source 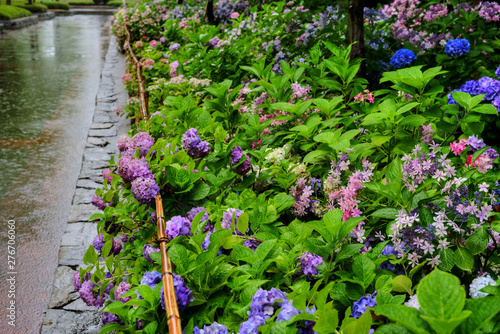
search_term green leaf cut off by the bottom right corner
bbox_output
[457,297,500,334]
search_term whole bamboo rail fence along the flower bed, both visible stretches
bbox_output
[124,22,182,334]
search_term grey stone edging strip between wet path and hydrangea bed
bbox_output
[40,36,130,334]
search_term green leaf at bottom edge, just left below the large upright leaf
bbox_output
[373,304,429,334]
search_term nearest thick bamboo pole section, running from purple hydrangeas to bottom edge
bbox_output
[156,194,182,334]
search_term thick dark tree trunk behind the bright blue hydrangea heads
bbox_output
[347,0,366,78]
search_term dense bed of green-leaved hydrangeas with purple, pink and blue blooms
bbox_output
[74,0,500,334]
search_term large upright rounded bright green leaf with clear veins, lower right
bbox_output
[417,269,465,320]
